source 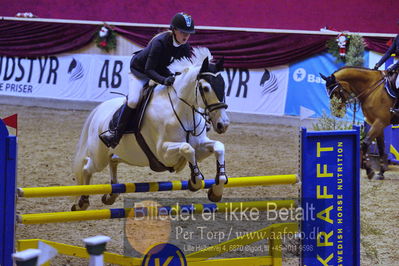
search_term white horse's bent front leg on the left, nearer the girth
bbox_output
[163,142,204,191]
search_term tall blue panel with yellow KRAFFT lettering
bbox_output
[301,128,360,265]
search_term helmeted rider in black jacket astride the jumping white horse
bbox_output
[100,12,195,148]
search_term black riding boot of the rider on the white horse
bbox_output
[99,103,134,149]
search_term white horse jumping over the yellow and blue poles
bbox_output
[72,48,229,210]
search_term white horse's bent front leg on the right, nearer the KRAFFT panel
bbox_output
[197,139,228,202]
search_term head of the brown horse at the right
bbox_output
[320,73,351,117]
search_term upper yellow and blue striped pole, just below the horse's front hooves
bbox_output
[18,175,297,198]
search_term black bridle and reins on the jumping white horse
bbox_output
[168,72,228,142]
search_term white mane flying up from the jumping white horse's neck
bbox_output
[168,47,212,73]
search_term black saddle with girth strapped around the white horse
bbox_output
[109,83,175,173]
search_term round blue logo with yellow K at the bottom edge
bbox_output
[141,243,187,266]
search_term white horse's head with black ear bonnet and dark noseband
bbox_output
[197,57,230,134]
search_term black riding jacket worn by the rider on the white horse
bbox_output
[130,32,191,84]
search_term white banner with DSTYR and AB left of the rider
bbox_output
[0,54,130,101]
